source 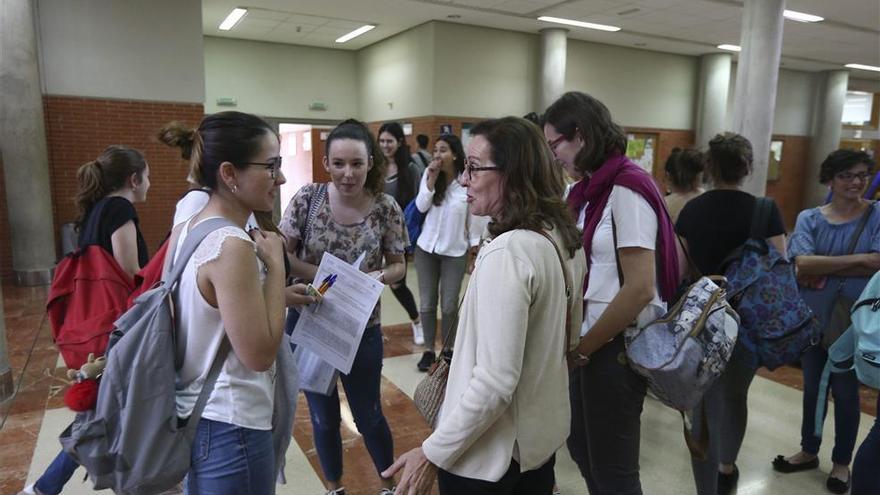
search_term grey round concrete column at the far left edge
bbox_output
[0,0,56,285]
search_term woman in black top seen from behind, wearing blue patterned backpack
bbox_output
[675,133,785,495]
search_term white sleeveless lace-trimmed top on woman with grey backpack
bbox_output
[173,219,275,430]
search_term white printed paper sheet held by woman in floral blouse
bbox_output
[292,252,385,373]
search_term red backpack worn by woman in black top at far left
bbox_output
[46,245,135,370]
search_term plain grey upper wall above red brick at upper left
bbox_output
[37,0,205,103]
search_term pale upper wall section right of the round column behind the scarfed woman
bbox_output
[565,40,700,129]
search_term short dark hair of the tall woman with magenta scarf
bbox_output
[544,91,626,174]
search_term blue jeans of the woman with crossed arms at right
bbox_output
[801,345,859,466]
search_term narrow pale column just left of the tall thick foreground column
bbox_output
[696,53,733,149]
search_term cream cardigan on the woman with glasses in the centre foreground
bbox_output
[422,230,587,482]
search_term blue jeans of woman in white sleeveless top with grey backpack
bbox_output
[184,418,275,495]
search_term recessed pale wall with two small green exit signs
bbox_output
[205,36,358,119]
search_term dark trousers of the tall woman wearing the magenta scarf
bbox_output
[569,335,647,495]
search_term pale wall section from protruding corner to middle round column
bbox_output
[433,22,539,117]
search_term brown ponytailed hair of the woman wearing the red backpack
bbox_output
[74,145,147,227]
